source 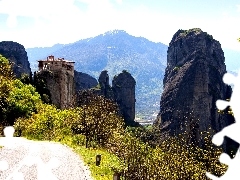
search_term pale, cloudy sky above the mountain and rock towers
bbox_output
[0,0,240,51]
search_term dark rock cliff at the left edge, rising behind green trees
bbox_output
[0,41,31,78]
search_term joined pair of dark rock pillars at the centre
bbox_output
[93,70,139,126]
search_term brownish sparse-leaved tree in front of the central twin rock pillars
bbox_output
[72,90,124,147]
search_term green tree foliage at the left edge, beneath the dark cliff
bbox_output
[0,55,41,125]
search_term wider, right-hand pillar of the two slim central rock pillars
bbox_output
[112,70,137,125]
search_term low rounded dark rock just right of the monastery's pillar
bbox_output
[74,71,98,92]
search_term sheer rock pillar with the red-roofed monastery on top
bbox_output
[34,56,75,109]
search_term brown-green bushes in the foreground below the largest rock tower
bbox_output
[106,128,227,180]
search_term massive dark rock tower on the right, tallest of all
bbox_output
[155,29,232,146]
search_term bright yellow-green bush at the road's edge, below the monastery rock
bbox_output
[14,104,74,140]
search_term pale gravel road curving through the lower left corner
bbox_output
[0,137,93,180]
